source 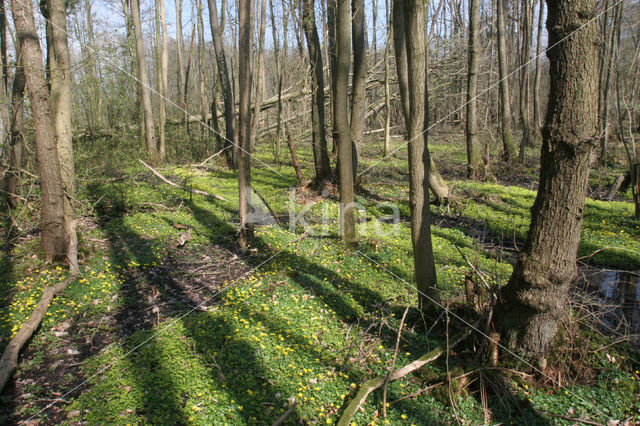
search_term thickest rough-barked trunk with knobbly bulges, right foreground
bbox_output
[496,0,598,365]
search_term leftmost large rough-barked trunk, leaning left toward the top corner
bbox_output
[11,0,67,262]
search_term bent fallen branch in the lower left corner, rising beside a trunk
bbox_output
[0,220,78,392]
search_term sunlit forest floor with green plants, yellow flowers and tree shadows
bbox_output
[0,131,640,424]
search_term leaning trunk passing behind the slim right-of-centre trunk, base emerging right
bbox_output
[392,1,449,203]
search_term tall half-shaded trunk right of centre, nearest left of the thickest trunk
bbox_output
[393,0,440,309]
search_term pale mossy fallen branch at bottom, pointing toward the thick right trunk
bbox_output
[338,330,470,426]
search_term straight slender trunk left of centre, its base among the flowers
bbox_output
[238,0,253,249]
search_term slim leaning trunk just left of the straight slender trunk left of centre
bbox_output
[208,0,236,168]
